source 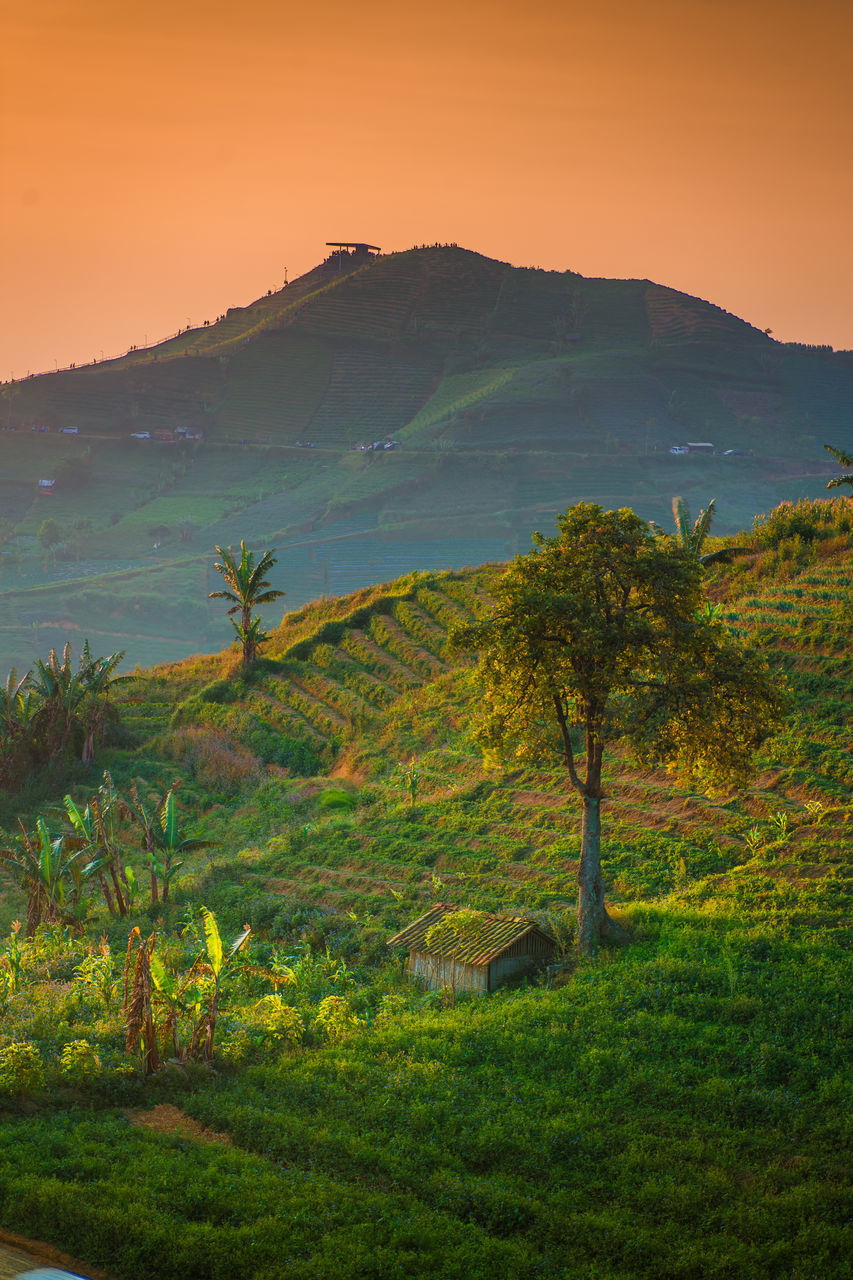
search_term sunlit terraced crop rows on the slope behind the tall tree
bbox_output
[112,509,853,942]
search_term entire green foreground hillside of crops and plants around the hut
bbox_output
[0,499,853,1280]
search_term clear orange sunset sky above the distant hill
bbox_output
[0,0,853,378]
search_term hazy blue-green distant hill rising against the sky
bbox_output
[0,247,853,671]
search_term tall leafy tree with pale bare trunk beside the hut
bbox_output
[455,503,783,954]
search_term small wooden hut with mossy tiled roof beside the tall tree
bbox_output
[388,902,557,995]
